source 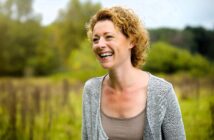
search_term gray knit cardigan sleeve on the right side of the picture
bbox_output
[162,86,186,140]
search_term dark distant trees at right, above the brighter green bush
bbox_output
[149,26,214,60]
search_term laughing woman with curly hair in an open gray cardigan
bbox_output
[82,7,185,140]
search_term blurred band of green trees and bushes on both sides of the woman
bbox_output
[0,0,214,77]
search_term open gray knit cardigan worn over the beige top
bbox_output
[82,74,186,140]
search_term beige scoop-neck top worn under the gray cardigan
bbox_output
[101,110,145,140]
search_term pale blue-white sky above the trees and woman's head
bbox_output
[33,0,214,29]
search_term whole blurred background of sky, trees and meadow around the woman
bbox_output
[0,0,214,140]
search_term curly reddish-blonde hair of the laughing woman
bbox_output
[86,6,149,67]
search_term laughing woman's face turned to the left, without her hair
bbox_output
[92,20,133,69]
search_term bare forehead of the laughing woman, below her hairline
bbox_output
[93,20,118,35]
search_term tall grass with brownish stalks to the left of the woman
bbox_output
[0,79,81,140]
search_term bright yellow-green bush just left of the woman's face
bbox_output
[68,39,105,81]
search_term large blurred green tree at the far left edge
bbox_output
[0,0,59,76]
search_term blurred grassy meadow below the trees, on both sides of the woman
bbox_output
[0,75,214,140]
